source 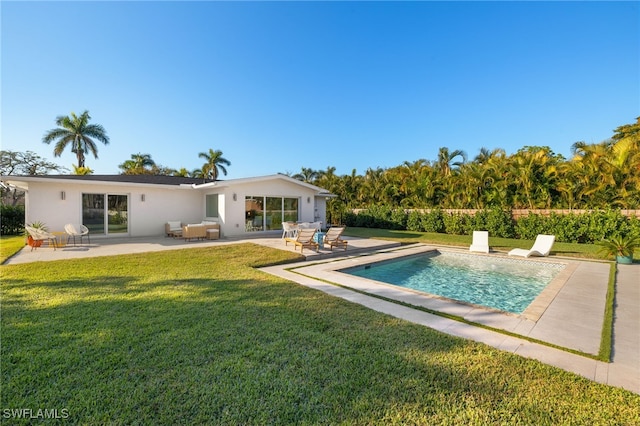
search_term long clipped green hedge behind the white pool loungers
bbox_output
[345,206,640,243]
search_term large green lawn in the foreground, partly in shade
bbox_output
[0,244,640,425]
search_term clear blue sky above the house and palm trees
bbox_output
[0,1,640,178]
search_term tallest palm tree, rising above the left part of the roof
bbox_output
[42,111,109,167]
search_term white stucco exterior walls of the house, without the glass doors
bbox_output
[15,176,326,238]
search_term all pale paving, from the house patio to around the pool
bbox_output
[5,234,640,394]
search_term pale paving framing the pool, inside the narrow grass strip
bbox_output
[288,244,610,356]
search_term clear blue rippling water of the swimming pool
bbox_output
[342,252,565,314]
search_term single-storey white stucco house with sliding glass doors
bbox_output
[1,174,334,238]
